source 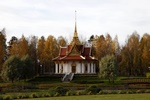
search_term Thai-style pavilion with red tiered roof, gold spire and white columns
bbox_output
[53,18,97,74]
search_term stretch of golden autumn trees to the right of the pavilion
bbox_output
[91,32,150,76]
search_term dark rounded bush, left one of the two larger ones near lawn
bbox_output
[49,86,68,96]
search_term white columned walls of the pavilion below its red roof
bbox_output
[55,61,96,74]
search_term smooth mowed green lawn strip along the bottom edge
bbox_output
[22,94,150,100]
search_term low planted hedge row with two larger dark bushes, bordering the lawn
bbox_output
[0,86,150,100]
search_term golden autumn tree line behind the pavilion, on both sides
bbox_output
[0,29,150,82]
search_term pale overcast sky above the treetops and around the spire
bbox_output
[0,0,150,44]
